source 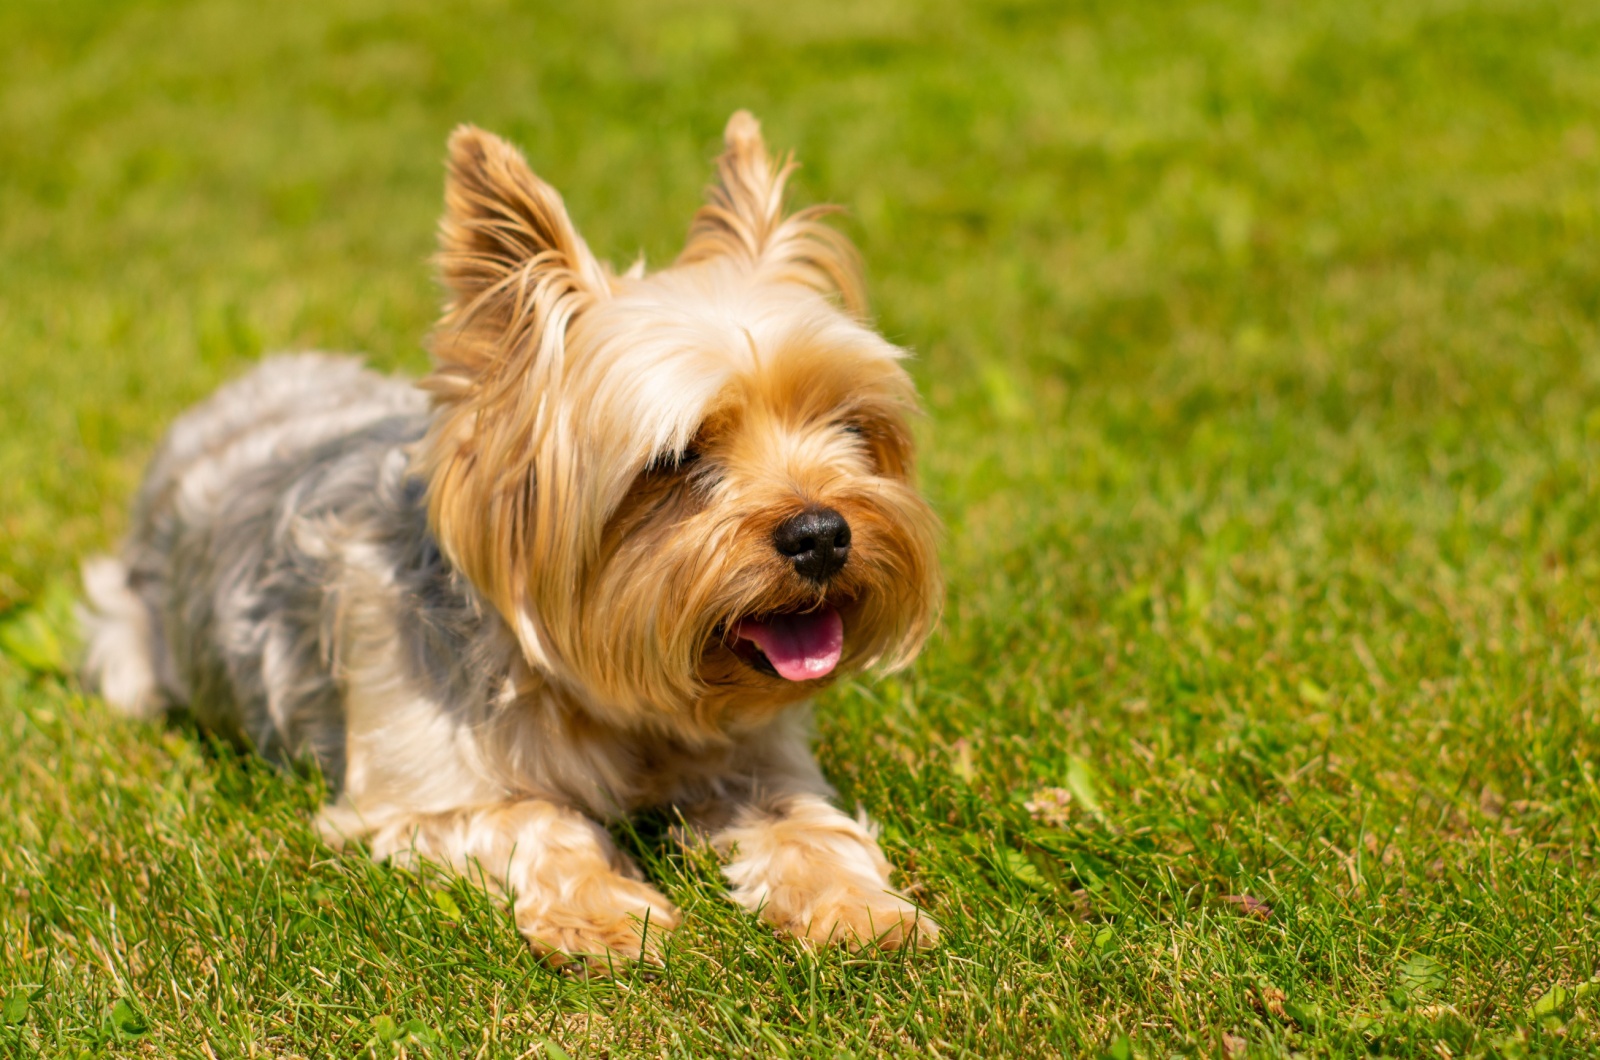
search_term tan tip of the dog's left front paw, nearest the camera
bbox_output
[517,879,678,972]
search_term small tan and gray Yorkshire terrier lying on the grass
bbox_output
[85,110,941,970]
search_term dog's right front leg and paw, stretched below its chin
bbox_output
[710,794,939,950]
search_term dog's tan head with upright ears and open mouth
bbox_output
[424,112,939,733]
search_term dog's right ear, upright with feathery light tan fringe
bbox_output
[678,110,867,317]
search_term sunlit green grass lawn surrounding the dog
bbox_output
[0,0,1600,1057]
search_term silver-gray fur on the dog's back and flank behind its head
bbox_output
[88,354,506,789]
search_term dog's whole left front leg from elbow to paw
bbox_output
[318,799,678,970]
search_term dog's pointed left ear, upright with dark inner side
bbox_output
[432,125,610,381]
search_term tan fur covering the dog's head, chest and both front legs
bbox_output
[363,112,939,956]
